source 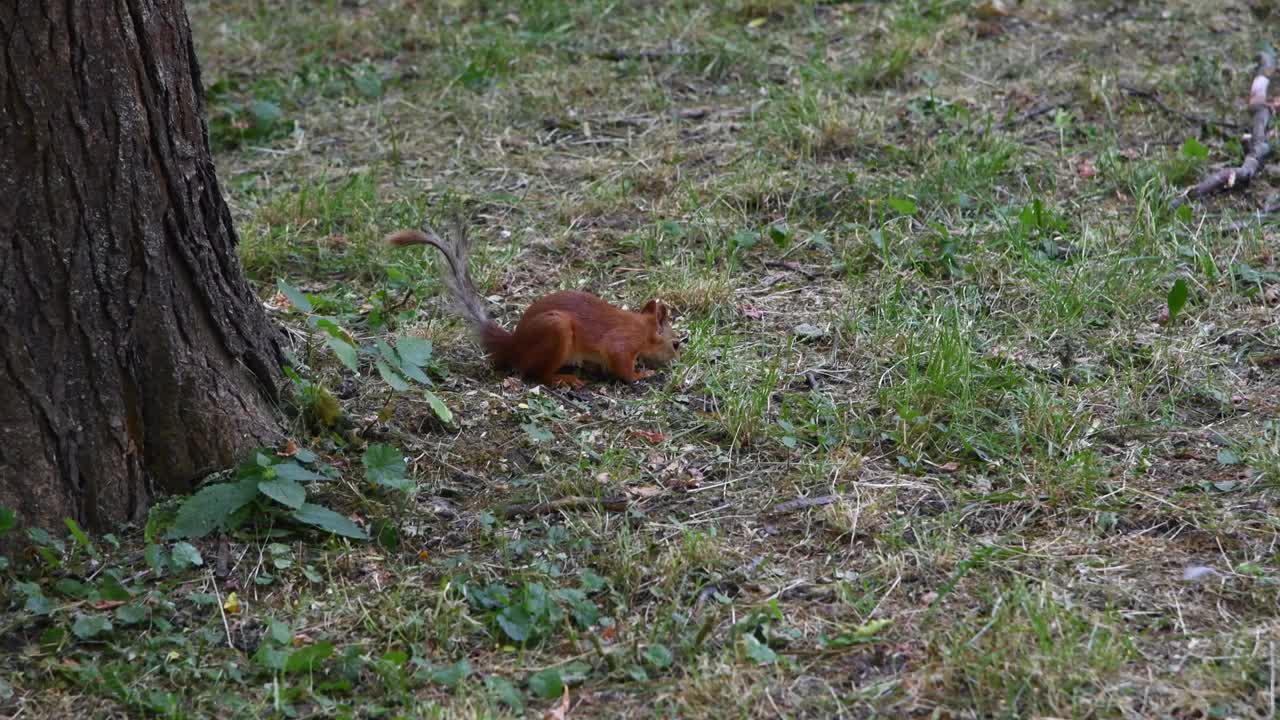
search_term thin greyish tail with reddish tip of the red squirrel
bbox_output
[387,220,512,369]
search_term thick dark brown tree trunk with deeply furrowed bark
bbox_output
[0,0,282,530]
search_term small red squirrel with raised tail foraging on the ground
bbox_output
[385,223,680,388]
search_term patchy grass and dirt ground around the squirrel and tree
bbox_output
[0,0,1280,717]
